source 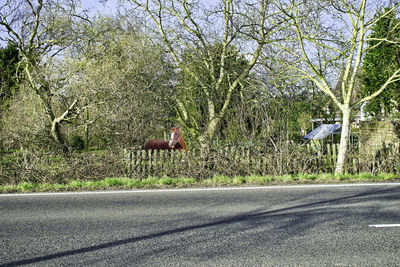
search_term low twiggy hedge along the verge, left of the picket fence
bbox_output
[0,151,124,185]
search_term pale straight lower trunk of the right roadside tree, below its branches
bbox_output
[335,105,351,175]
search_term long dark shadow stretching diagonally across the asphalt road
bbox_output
[0,187,400,266]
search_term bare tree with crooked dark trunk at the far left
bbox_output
[0,0,88,152]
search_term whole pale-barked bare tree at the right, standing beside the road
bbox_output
[276,0,400,174]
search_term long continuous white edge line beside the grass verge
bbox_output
[0,183,400,197]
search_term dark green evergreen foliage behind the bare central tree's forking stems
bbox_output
[176,43,248,142]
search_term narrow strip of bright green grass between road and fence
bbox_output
[0,173,400,193]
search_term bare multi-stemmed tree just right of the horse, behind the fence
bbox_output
[131,0,279,148]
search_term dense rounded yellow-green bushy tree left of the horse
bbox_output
[70,17,175,147]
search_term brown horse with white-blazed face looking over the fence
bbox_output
[144,127,188,151]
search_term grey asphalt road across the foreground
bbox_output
[0,184,400,267]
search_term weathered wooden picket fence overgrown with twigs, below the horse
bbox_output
[123,145,400,179]
